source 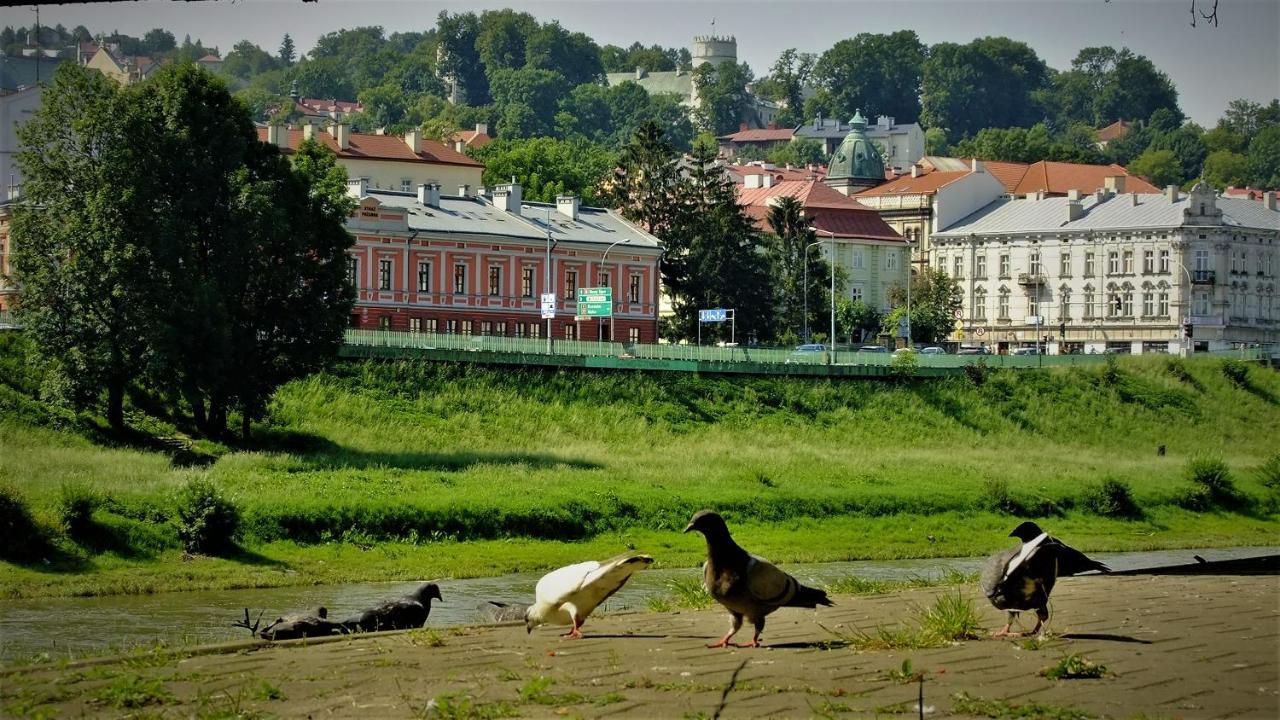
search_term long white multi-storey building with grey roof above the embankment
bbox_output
[931,183,1280,352]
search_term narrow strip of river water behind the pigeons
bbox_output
[0,547,1280,662]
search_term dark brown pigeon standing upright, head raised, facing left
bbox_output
[685,510,835,647]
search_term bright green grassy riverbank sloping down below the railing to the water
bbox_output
[0,333,1280,597]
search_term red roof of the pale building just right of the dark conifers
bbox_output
[737,179,905,242]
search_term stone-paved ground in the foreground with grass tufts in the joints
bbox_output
[0,575,1280,719]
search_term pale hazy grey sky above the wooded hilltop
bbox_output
[20,0,1280,126]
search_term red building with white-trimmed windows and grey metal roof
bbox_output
[347,178,662,342]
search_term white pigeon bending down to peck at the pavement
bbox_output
[525,552,653,638]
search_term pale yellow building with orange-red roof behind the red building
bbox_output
[257,124,484,195]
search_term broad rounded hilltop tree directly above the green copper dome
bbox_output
[813,29,927,123]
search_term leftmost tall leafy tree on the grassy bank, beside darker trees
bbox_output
[10,63,163,430]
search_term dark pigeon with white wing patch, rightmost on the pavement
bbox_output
[980,521,1111,637]
